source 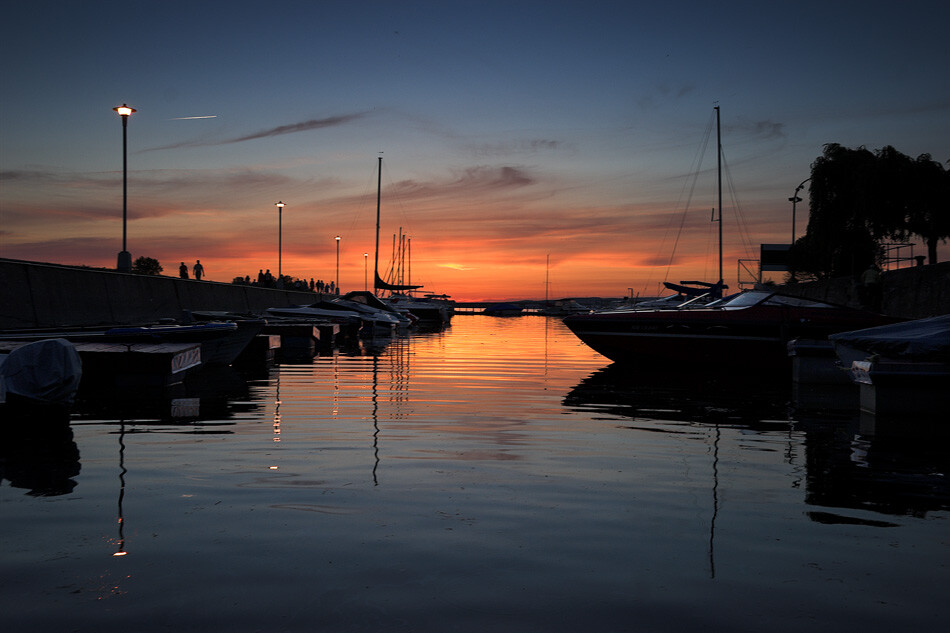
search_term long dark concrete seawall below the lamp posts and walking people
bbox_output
[0,258,318,328]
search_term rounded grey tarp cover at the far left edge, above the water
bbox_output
[0,338,82,404]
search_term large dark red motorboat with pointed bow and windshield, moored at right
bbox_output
[564,290,901,370]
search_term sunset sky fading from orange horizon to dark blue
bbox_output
[0,0,950,300]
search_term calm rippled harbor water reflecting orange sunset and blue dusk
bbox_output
[0,315,950,633]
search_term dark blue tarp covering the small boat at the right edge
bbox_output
[828,314,950,361]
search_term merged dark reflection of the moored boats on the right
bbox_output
[564,363,950,527]
